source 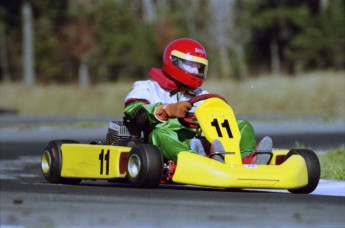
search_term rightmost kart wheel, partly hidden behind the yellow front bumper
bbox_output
[285,149,321,194]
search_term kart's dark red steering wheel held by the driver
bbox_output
[178,93,228,128]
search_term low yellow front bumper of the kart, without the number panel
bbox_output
[173,152,308,189]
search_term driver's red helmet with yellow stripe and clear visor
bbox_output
[162,38,208,89]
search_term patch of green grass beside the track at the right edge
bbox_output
[319,146,345,180]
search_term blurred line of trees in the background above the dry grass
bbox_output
[0,0,345,84]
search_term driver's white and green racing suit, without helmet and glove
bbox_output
[124,80,256,162]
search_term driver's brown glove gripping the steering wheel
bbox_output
[155,101,193,121]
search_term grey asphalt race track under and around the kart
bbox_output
[0,116,345,227]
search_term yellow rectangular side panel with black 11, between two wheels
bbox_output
[61,144,131,179]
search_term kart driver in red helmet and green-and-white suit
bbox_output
[124,38,270,163]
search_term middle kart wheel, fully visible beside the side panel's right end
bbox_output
[127,144,163,188]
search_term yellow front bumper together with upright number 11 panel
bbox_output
[173,98,308,189]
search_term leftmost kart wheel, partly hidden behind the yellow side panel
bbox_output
[41,140,81,184]
